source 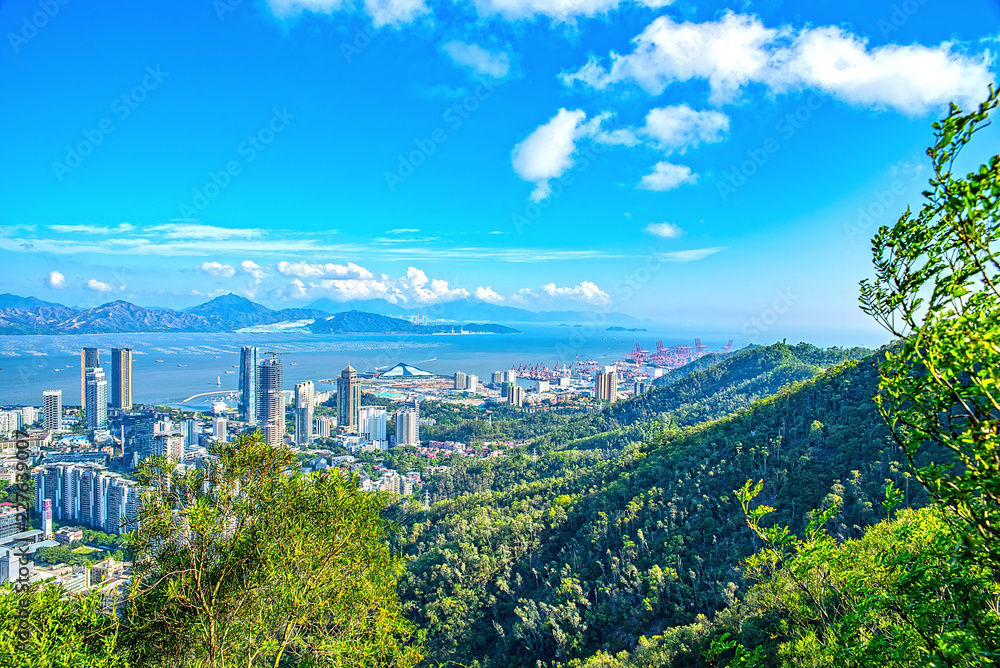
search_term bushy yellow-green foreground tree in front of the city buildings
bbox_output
[126,432,422,668]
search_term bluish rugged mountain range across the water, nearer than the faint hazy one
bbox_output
[0,294,517,334]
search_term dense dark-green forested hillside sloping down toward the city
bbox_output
[401,344,908,666]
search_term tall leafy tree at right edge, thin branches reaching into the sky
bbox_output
[861,89,1000,576]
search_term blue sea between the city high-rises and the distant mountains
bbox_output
[0,324,741,410]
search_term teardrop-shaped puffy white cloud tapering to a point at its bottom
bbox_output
[511,109,587,202]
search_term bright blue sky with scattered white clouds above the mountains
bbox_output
[0,0,1000,343]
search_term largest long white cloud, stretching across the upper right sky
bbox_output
[561,12,993,114]
